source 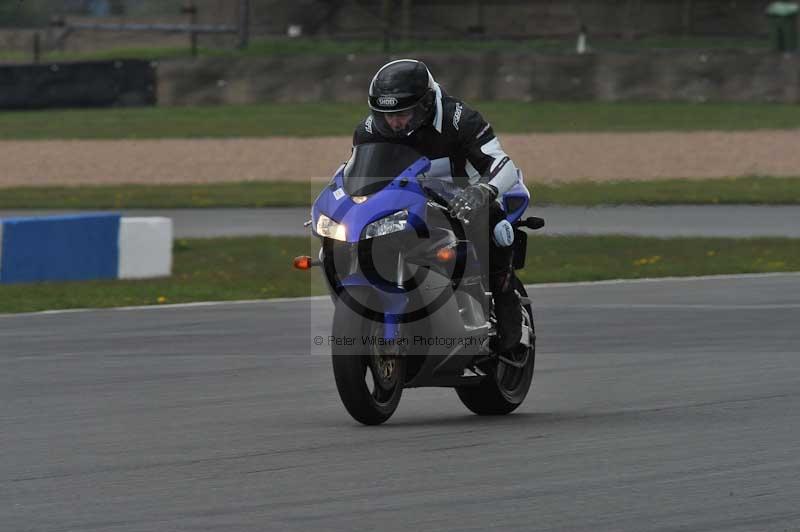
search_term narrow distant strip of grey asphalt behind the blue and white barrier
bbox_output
[0,205,800,238]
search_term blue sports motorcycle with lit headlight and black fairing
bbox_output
[295,143,544,425]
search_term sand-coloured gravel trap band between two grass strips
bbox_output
[0,130,800,187]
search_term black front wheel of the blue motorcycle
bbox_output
[331,300,406,425]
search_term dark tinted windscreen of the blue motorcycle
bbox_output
[343,142,422,196]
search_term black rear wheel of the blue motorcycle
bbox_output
[456,276,536,416]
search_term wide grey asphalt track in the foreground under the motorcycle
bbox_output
[0,274,800,532]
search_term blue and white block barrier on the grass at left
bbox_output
[0,214,172,283]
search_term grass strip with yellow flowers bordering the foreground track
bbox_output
[0,236,800,313]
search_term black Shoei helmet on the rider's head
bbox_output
[368,59,435,137]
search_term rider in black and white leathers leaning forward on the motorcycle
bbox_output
[353,59,522,353]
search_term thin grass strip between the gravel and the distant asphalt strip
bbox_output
[0,177,800,209]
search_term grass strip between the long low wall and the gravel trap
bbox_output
[0,101,800,140]
